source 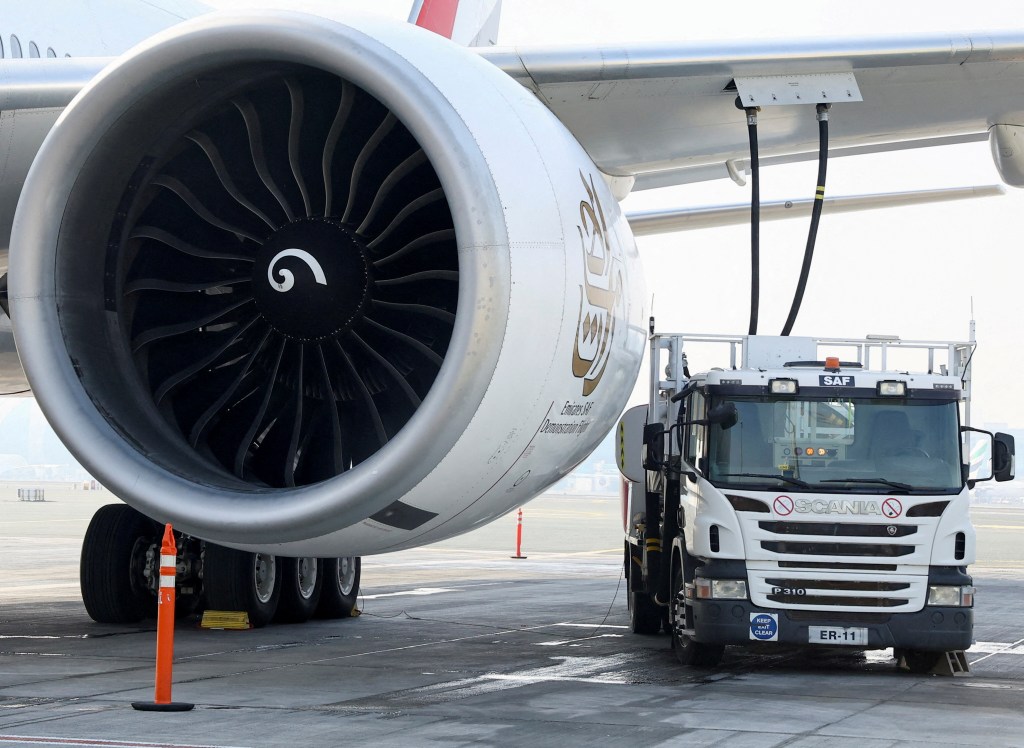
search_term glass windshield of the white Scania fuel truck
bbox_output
[708,397,963,494]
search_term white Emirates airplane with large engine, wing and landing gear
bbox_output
[0,0,1024,625]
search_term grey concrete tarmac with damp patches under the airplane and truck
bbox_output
[0,492,1024,748]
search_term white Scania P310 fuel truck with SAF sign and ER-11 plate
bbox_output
[621,335,1014,670]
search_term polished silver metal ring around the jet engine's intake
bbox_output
[10,11,511,543]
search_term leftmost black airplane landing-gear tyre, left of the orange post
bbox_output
[79,504,159,623]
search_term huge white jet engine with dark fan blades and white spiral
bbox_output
[10,12,645,555]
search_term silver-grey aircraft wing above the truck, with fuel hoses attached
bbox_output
[481,32,1024,189]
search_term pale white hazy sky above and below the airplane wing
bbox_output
[210,0,1024,426]
